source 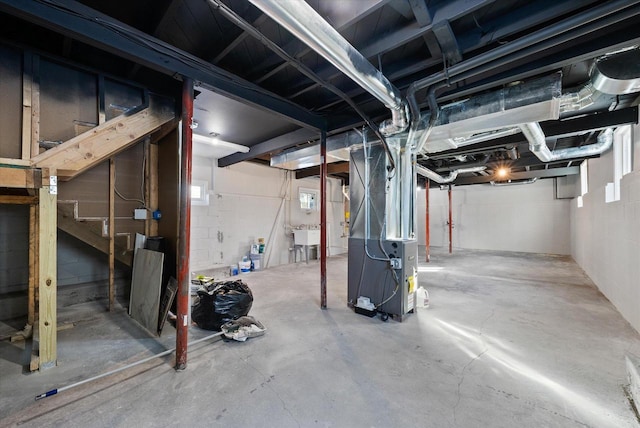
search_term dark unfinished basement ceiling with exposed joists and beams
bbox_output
[0,0,640,185]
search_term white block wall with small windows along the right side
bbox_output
[571,122,640,331]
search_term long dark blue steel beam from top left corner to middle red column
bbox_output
[0,0,325,129]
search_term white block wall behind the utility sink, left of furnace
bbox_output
[190,157,346,272]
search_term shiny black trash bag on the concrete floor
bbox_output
[191,279,253,331]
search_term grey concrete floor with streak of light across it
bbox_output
[0,249,640,428]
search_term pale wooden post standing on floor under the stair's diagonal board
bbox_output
[38,174,58,370]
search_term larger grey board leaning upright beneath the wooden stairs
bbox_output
[129,248,164,334]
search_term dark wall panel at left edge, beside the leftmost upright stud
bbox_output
[0,46,22,159]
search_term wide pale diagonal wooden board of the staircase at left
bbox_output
[32,97,174,181]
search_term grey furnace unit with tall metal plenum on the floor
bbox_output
[347,131,418,321]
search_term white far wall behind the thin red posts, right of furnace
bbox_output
[417,179,571,254]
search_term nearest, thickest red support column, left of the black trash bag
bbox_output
[175,77,193,370]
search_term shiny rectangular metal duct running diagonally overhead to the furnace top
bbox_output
[250,0,408,133]
